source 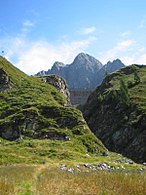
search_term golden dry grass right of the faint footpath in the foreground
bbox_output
[36,170,146,195]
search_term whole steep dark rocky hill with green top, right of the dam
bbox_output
[83,65,146,162]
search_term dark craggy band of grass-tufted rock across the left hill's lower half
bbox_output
[0,105,107,155]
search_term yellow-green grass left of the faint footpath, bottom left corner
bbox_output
[0,165,35,195]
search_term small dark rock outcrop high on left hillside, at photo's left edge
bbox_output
[0,68,12,92]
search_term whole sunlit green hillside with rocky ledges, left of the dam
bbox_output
[0,57,107,164]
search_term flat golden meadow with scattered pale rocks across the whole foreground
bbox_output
[0,163,146,195]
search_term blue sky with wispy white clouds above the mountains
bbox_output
[0,0,146,74]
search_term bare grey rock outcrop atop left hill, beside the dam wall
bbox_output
[43,75,70,103]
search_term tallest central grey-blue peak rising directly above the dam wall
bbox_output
[66,53,103,89]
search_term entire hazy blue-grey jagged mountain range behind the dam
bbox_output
[36,53,125,89]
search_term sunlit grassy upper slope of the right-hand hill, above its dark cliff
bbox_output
[85,65,146,125]
